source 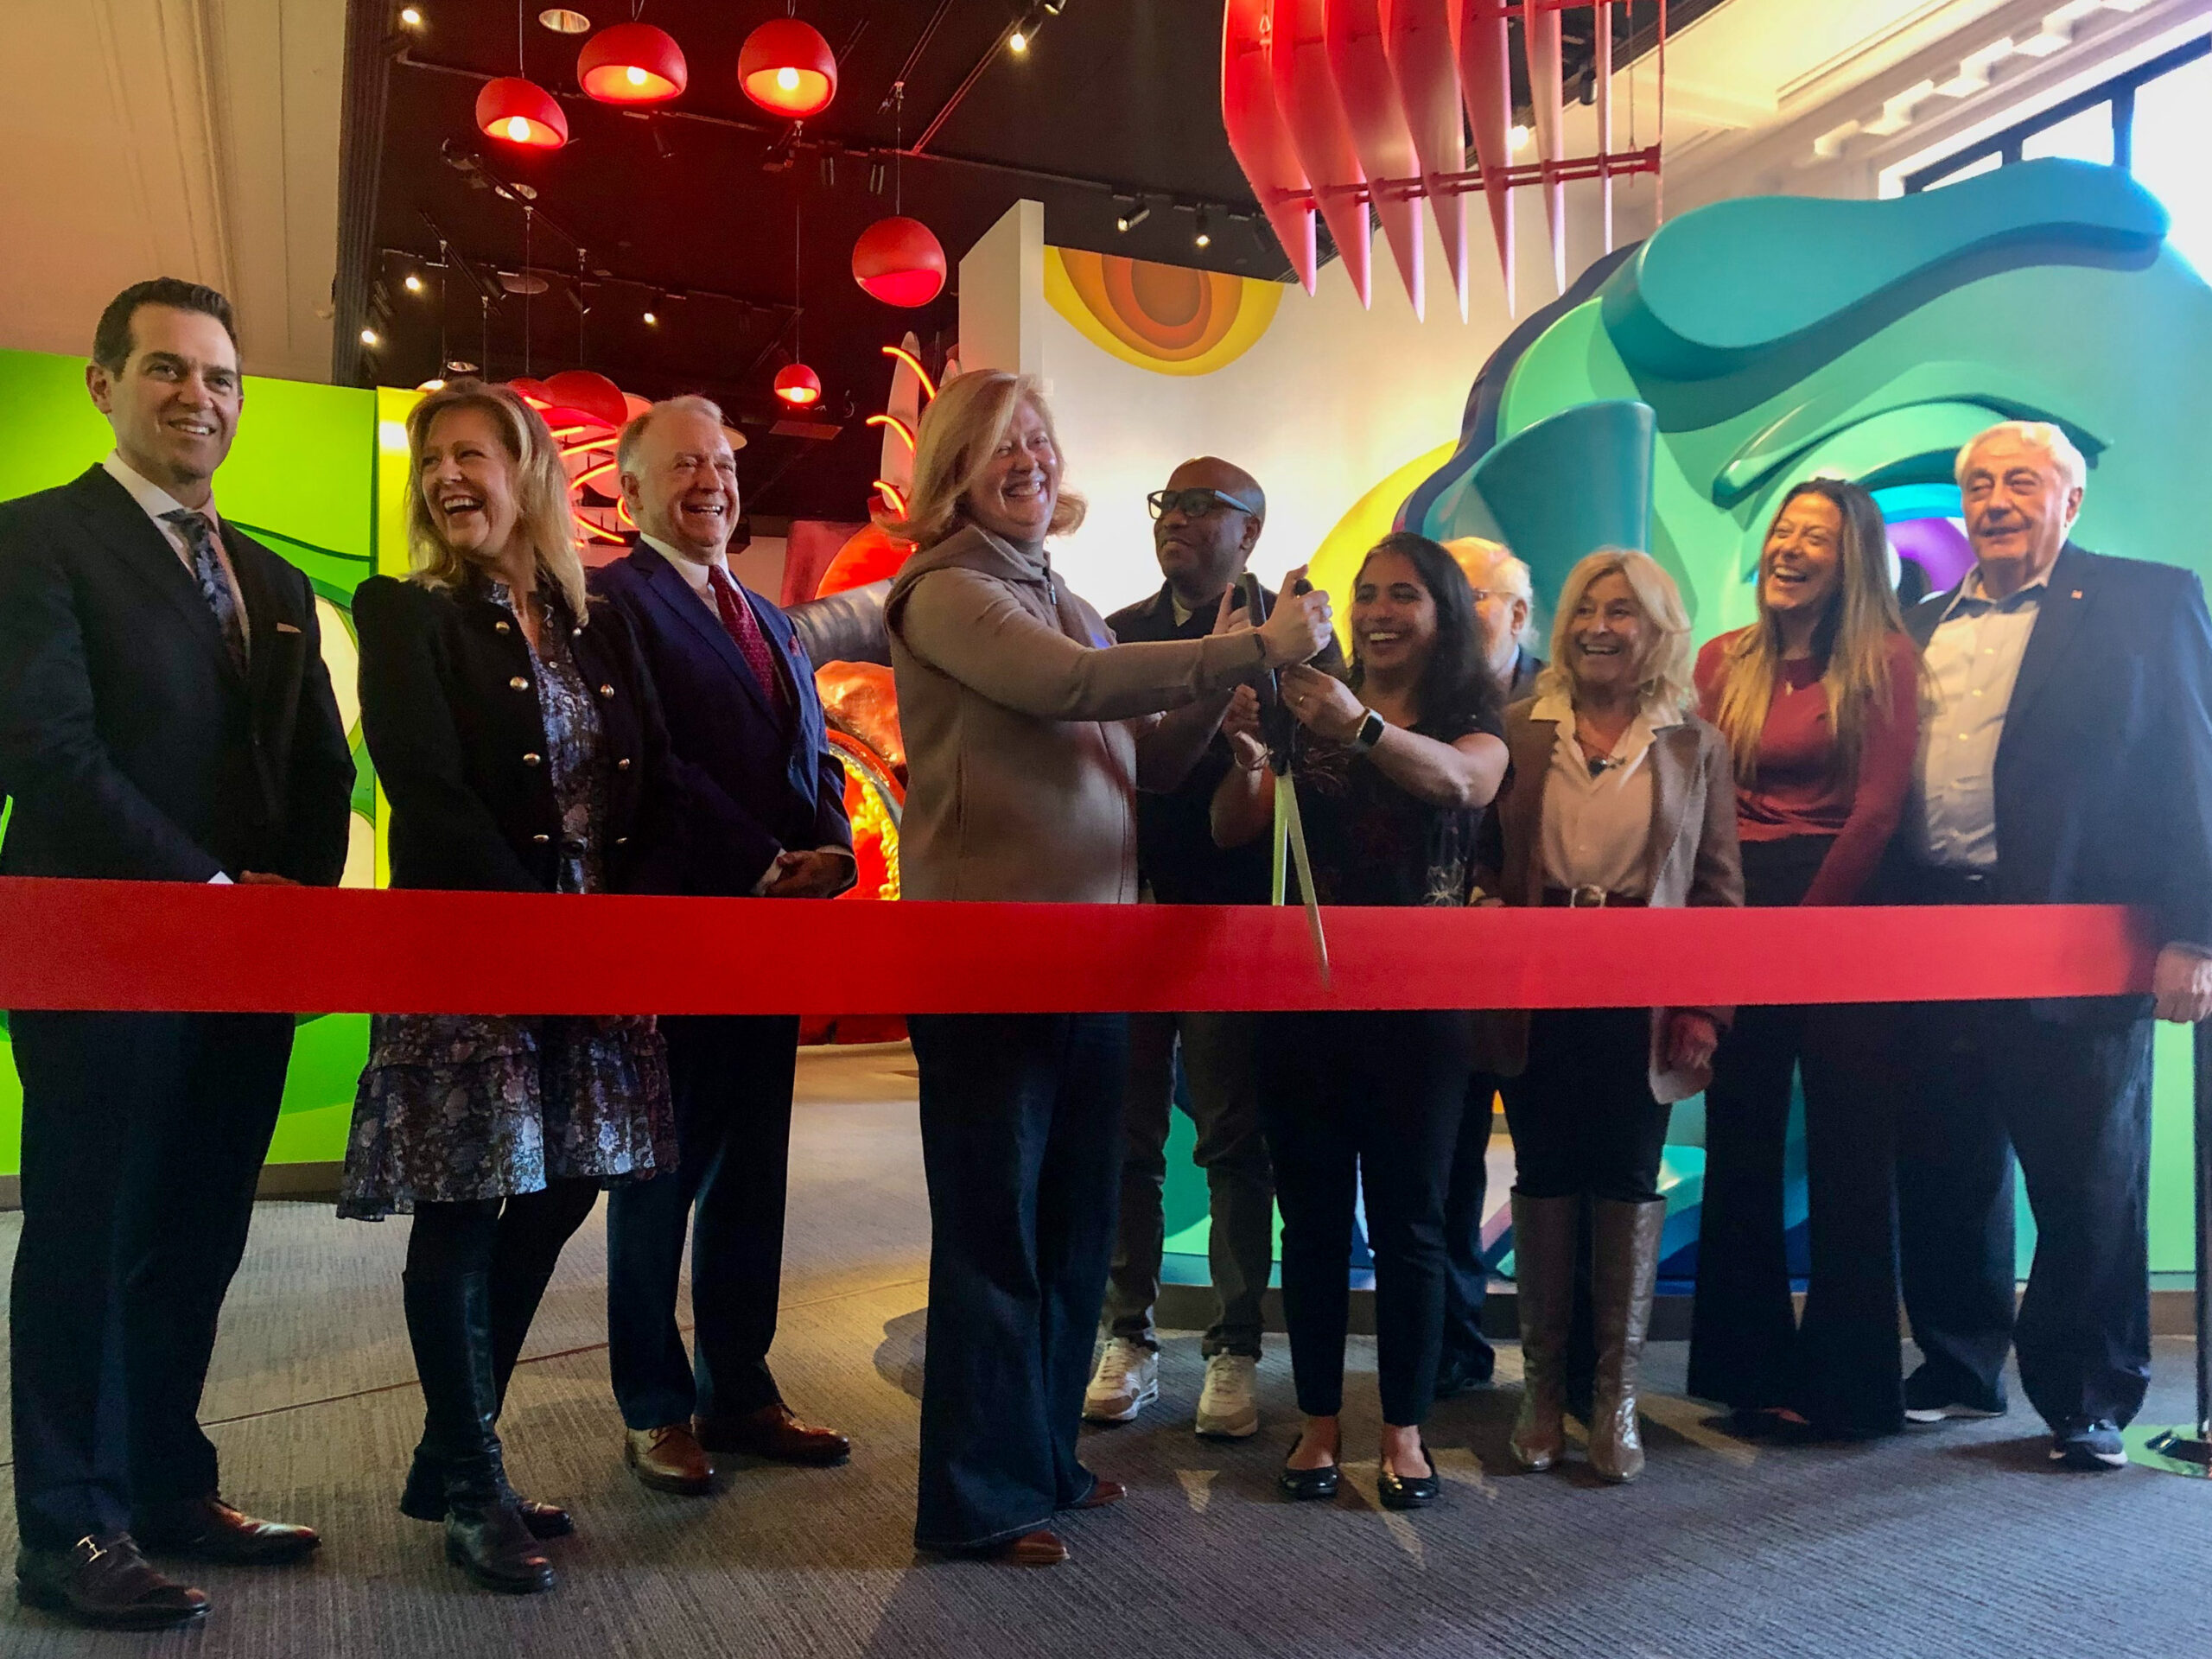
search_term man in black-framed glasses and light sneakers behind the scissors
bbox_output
[1084,455,1274,1440]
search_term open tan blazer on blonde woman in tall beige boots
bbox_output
[1478,699,1743,1102]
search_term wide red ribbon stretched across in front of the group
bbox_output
[0,878,2157,1013]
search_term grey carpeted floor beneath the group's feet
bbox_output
[0,1048,2212,1659]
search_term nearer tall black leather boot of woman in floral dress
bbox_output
[403,1272,553,1595]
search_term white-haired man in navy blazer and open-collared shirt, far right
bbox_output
[1887,423,2212,1469]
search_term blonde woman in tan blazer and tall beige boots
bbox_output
[1480,549,1743,1480]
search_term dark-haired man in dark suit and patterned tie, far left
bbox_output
[0,279,354,1626]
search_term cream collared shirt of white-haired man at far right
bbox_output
[1911,569,2050,869]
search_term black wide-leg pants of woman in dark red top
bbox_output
[1690,836,1904,1435]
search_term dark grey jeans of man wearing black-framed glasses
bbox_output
[1103,1013,1274,1358]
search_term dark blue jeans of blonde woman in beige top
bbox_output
[907,1013,1128,1551]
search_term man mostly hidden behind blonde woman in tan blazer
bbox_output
[1435,536,1539,1400]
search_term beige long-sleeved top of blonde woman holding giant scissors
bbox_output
[885,524,1261,905]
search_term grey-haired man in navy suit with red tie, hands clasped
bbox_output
[591,398,854,1493]
